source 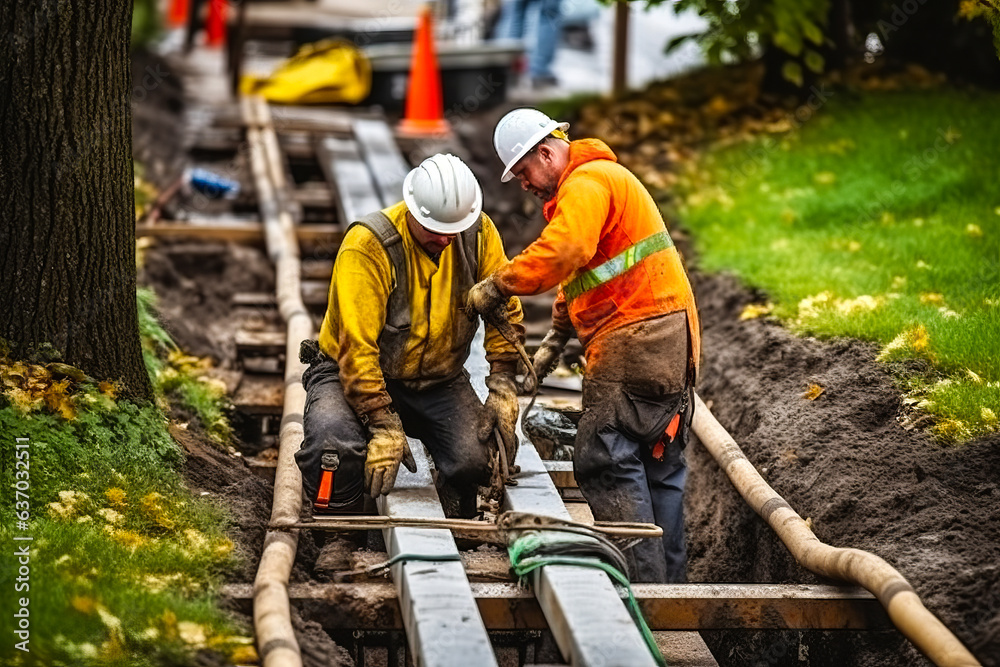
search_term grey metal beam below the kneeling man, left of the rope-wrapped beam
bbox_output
[378,440,497,667]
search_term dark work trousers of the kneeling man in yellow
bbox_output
[295,360,490,516]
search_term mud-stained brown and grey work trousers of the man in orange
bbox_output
[573,313,693,582]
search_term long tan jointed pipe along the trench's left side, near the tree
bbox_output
[242,97,313,667]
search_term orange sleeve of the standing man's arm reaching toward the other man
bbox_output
[496,166,611,295]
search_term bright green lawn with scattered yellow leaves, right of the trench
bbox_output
[678,89,1000,441]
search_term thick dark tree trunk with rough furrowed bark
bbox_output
[0,0,152,399]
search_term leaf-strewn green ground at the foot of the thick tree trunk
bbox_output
[0,295,254,667]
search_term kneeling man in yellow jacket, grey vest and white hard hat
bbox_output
[296,154,524,517]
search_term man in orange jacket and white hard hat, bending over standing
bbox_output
[468,109,700,581]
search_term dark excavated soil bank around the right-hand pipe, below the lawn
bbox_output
[687,274,1000,667]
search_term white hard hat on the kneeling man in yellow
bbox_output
[403,153,483,234]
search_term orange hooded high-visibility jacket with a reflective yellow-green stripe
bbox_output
[495,139,701,376]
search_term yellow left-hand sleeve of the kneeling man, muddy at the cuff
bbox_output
[330,240,392,415]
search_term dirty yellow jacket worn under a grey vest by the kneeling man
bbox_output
[319,202,523,415]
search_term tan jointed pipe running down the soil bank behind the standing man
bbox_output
[694,396,980,667]
